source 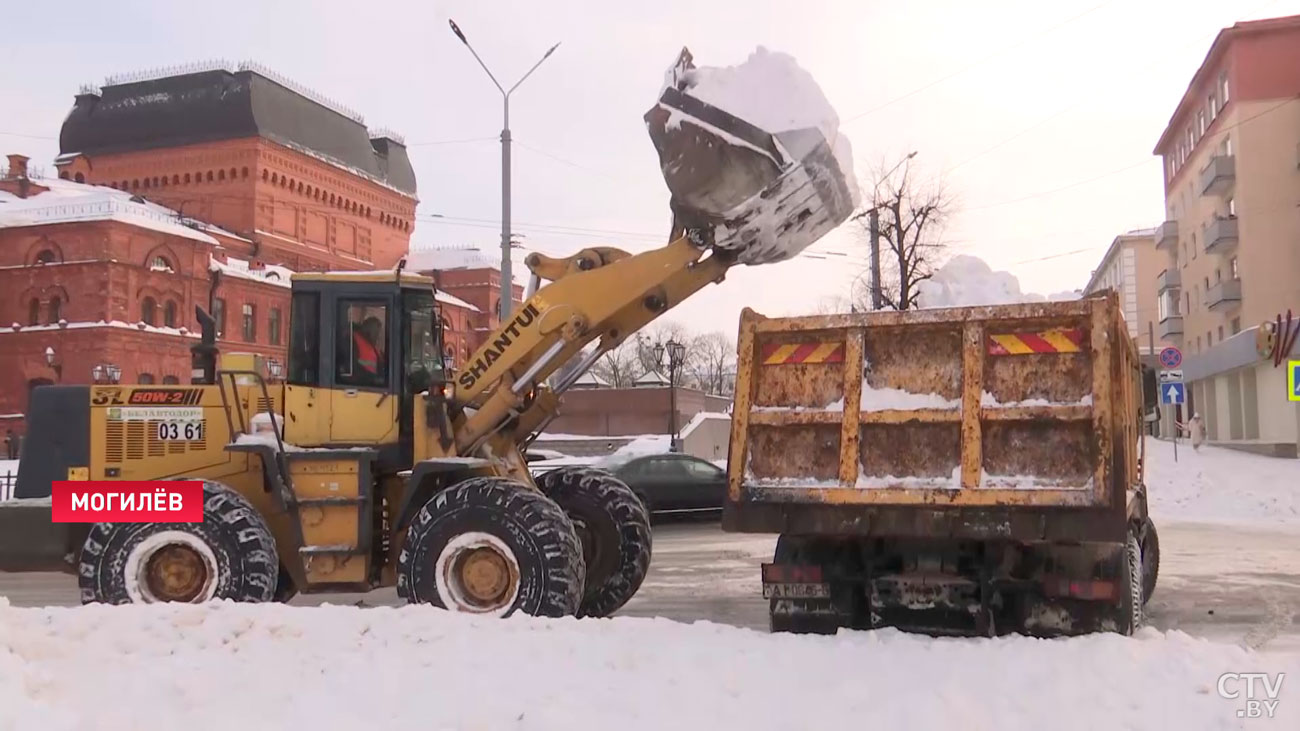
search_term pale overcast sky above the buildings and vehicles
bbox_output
[0,0,1300,333]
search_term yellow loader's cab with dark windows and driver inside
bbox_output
[285,272,447,473]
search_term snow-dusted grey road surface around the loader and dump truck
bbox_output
[0,523,1300,652]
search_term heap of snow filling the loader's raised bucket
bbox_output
[670,46,861,207]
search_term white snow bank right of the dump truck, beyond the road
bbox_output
[1145,438,1300,529]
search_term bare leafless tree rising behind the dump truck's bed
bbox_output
[850,155,954,310]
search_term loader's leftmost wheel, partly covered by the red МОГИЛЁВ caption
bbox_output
[77,481,280,604]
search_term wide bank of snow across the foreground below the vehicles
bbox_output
[0,600,1300,731]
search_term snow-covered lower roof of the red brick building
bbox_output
[0,178,219,245]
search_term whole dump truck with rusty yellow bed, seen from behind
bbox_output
[723,293,1160,636]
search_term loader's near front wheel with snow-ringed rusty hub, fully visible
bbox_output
[398,477,585,617]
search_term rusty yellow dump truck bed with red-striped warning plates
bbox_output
[723,294,1141,538]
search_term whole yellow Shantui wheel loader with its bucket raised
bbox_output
[0,51,855,617]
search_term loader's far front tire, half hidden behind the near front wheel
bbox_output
[537,467,653,617]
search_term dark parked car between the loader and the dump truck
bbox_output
[597,454,727,514]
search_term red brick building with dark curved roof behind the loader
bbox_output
[0,65,519,433]
